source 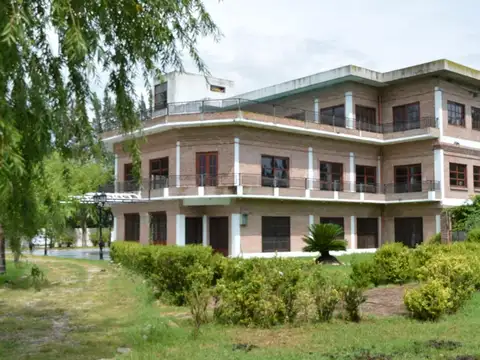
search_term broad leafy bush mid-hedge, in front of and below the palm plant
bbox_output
[214,258,308,327]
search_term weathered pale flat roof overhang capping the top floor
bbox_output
[235,59,480,101]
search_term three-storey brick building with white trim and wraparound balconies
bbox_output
[104,60,480,256]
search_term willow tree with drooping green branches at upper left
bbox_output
[0,0,219,273]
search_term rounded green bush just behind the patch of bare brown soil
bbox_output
[373,243,413,284]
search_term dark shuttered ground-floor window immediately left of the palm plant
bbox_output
[262,216,290,252]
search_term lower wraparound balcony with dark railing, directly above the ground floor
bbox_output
[99,174,440,203]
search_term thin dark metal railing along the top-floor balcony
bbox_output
[103,99,437,134]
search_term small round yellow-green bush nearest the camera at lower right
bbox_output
[404,279,452,321]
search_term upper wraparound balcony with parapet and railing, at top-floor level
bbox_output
[103,99,439,142]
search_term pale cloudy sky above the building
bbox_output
[173,0,480,93]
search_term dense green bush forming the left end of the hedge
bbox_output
[111,241,221,305]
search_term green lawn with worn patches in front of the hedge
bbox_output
[0,253,480,360]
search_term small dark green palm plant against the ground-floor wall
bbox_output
[303,224,347,264]
